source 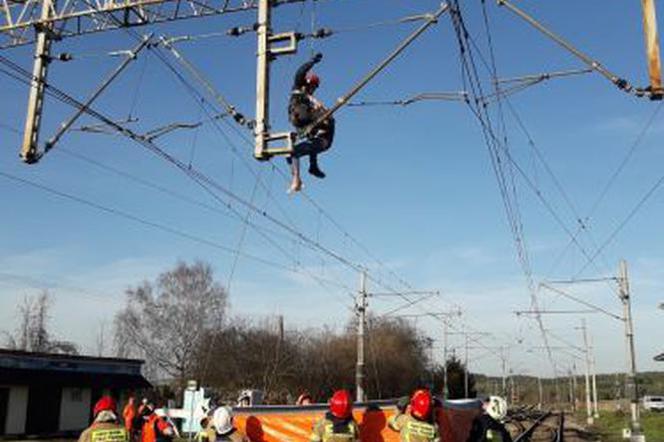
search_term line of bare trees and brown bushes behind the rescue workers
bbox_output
[115,262,474,403]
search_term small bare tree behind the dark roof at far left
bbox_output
[5,290,78,354]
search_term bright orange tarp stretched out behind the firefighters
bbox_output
[235,407,478,442]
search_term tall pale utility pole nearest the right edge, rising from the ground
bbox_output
[618,260,646,442]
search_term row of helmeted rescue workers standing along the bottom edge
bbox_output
[79,389,512,442]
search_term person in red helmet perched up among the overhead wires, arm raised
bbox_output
[288,52,334,192]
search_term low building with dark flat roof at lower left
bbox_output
[0,349,150,436]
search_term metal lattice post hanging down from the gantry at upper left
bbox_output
[21,0,56,164]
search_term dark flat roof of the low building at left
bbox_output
[0,349,150,389]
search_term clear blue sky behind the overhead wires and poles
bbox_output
[0,0,664,380]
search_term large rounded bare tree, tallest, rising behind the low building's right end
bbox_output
[114,262,227,386]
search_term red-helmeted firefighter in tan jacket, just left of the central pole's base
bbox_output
[309,390,360,442]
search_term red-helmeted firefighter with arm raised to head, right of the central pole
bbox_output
[387,389,440,442]
